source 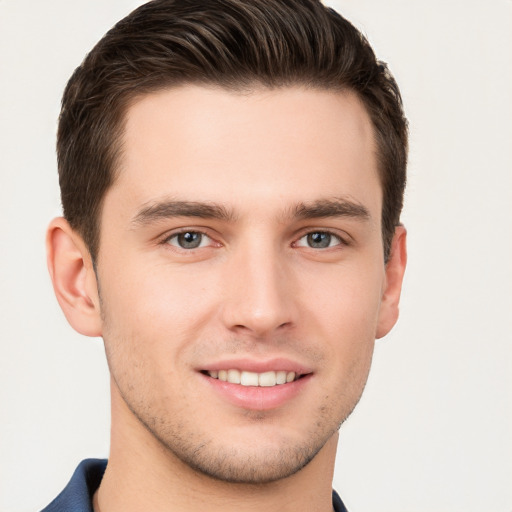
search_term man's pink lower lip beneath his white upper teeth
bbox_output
[200,374,312,411]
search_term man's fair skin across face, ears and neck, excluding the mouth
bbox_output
[48,86,406,512]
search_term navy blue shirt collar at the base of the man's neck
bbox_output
[41,459,347,512]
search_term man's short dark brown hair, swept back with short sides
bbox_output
[57,0,407,260]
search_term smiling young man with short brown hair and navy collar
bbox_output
[45,0,407,512]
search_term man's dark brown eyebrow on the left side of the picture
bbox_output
[132,200,235,225]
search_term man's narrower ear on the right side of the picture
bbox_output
[376,226,407,338]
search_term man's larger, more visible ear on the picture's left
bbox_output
[46,217,102,336]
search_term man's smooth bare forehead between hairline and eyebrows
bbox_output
[106,86,381,218]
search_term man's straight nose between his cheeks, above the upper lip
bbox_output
[222,241,297,338]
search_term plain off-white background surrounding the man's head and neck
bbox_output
[0,0,512,512]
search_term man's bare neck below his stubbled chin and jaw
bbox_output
[93,386,338,512]
